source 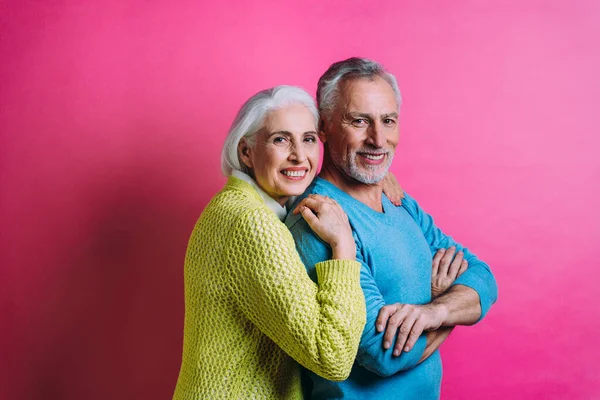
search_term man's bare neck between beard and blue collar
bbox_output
[319,154,383,212]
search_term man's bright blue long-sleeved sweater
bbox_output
[286,178,498,400]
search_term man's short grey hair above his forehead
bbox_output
[317,57,402,123]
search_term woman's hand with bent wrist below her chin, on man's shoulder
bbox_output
[293,194,356,260]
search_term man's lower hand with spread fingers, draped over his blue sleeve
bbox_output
[376,303,446,356]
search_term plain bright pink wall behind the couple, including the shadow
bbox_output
[0,0,600,400]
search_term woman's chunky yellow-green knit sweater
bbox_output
[174,177,365,400]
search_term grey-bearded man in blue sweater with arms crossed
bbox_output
[286,58,497,400]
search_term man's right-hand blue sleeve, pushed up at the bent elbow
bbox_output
[402,193,498,320]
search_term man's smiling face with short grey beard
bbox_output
[320,77,400,184]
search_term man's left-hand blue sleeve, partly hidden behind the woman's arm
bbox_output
[286,216,427,377]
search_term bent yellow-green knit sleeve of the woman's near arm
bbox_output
[224,209,365,380]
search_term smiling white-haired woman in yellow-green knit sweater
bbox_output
[174,86,365,399]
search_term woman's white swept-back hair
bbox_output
[221,85,319,176]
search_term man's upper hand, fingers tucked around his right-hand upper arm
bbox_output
[431,246,469,300]
